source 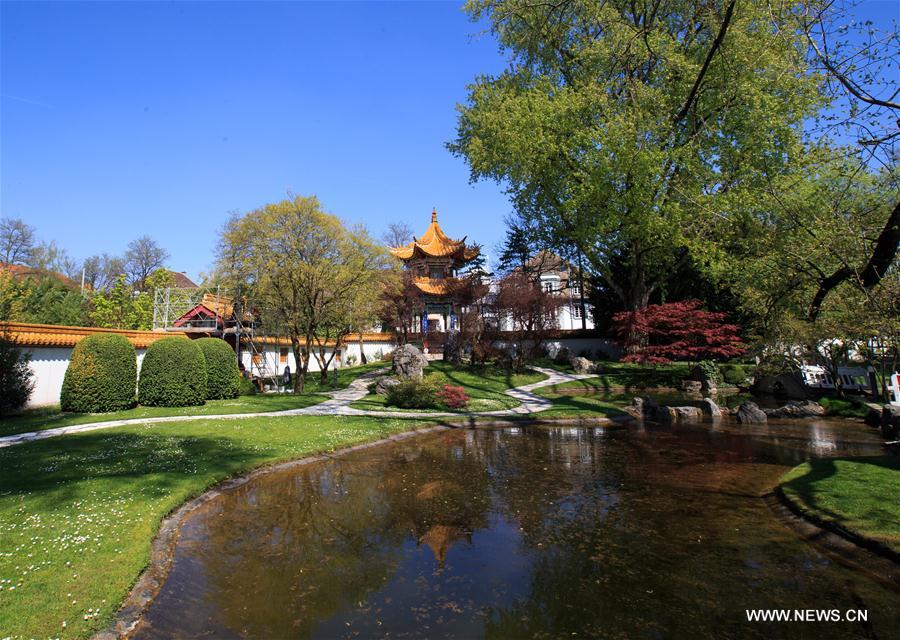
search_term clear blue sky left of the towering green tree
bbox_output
[0,2,510,276]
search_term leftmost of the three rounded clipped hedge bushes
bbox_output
[59,333,137,413]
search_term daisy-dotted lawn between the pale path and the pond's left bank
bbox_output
[0,416,421,638]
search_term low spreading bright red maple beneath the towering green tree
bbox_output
[613,300,746,364]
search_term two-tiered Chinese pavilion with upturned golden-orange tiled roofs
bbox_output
[391,211,479,333]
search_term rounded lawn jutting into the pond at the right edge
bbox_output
[781,456,900,553]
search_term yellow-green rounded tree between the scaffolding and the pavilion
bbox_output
[219,197,389,393]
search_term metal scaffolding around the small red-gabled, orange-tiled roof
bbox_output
[153,286,278,384]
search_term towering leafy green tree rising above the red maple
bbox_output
[449,0,821,309]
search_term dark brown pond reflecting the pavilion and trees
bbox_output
[135,421,900,639]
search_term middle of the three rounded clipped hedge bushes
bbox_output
[138,336,206,407]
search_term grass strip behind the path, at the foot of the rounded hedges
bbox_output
[0,362,386,436]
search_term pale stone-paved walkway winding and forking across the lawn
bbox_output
[0,367,595,448]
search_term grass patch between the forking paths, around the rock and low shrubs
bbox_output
[350,360,547,413]
